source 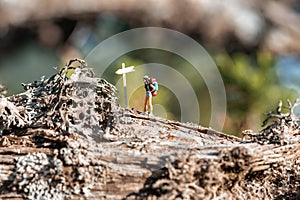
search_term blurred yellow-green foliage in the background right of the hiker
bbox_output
[215,51,296,132]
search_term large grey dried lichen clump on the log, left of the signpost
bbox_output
[0,59,116,139]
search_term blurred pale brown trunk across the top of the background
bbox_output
[0,0,300,53]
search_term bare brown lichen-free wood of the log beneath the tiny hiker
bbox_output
[0,113,238,199]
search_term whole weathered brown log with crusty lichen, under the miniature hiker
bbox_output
[0,58,300,199]
